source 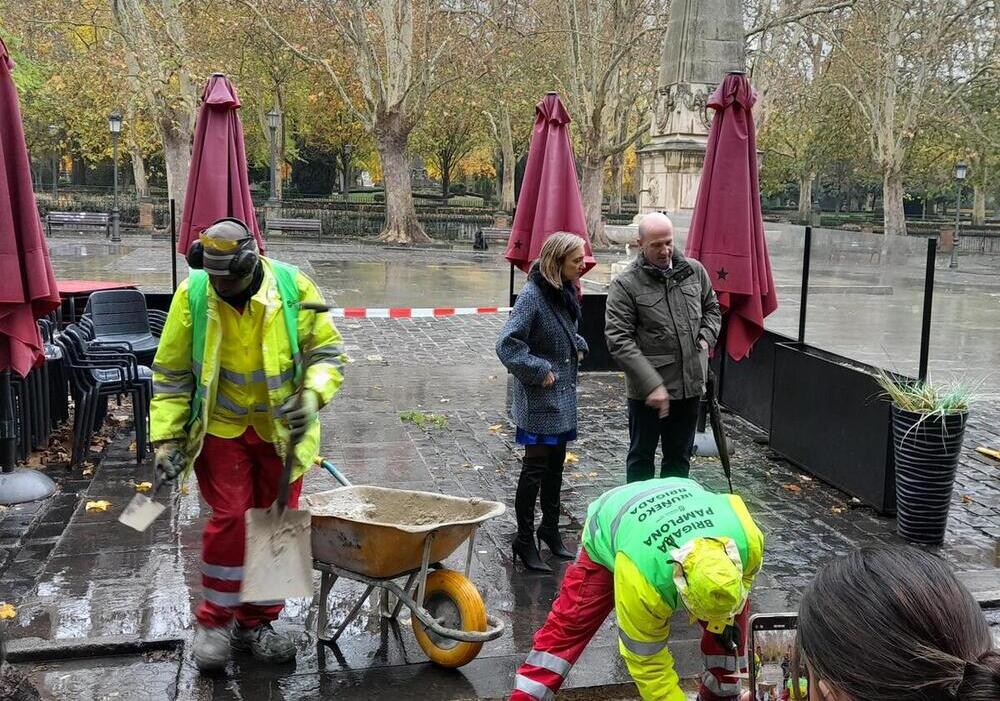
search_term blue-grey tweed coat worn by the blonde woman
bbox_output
[496,268,588,435]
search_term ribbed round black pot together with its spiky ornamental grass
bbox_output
[878,372,973,545]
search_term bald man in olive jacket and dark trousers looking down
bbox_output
[605,212,722,482]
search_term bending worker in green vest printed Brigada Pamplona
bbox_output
[511,477,764,701]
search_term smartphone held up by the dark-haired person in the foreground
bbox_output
[747,613,806,701]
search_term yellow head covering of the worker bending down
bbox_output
[671,538,750,633]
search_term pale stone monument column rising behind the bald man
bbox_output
[637,0,746,214]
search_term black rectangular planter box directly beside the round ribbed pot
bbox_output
[768,343,896,514]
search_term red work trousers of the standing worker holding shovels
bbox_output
[194,428,302,628]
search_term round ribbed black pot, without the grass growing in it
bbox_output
[892,405,968,545]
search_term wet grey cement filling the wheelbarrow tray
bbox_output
[303,489,490,526]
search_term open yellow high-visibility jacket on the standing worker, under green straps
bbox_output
[150,258,347,481]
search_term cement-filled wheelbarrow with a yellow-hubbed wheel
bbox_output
[299,459,505,668]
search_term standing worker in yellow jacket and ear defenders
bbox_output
[151,219,346,671]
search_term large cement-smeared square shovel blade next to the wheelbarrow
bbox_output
[240,509,313,602]
